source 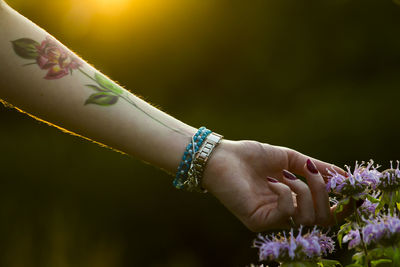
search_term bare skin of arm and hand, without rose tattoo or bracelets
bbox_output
[0,0,348,231]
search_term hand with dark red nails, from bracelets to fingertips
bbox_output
[203,140,349,232]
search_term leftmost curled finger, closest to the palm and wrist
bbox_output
[266,177,295,228]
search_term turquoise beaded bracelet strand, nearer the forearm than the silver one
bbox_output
[173,126,211,189]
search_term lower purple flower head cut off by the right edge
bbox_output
[343,215,400,248]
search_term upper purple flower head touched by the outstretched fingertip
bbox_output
[326,160,382,196]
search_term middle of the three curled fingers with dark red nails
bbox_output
[283,170,315,225]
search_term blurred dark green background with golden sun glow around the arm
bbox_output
[0,0,400,267]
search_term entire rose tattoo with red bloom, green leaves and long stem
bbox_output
[11,36,183,134]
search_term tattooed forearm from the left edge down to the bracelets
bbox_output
[0,2,196,173]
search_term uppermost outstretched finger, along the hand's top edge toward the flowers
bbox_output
[287,149,346,180]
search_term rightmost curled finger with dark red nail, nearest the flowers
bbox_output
[303,159,331,226]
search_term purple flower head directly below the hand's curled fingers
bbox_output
[254,227,335,261]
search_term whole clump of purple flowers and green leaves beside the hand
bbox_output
[254,160,400,267]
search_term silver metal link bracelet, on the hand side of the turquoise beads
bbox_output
[184,133,223,193]
